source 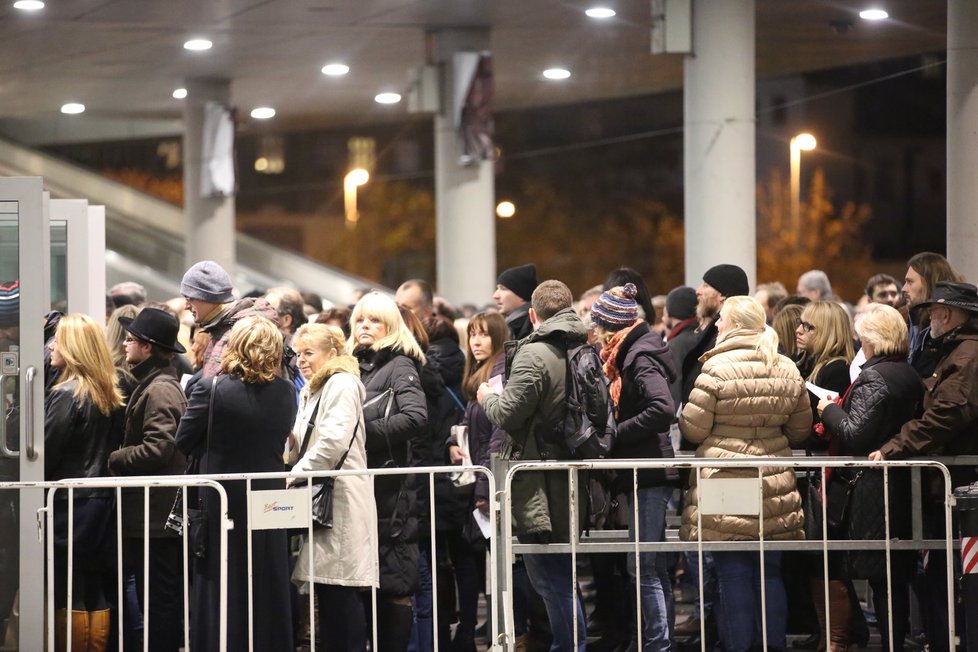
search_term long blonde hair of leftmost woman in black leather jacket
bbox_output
[54,313,123,415]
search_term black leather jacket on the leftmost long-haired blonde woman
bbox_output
[44,380,125,498]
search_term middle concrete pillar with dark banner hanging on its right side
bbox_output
[433,29,496,305]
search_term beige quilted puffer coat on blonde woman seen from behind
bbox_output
[679,329,812,541]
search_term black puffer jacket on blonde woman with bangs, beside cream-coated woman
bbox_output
[354,348,428,597]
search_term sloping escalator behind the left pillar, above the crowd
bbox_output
[0,134,377,304]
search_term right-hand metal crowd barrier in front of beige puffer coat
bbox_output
[493,456,964,650]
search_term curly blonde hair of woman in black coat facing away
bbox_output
[221,315,283,384]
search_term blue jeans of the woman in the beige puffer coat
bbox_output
[713,551,788,652]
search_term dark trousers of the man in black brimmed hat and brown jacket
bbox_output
[122,537,183,652]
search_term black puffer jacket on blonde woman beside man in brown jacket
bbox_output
[822,356,924,579]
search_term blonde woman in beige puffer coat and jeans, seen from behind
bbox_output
[679,296,812,652]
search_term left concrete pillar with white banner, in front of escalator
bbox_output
[183,78,235,277]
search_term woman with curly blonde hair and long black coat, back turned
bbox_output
[176,316,296,652]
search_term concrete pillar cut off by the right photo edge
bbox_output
[947,0,978,283]
